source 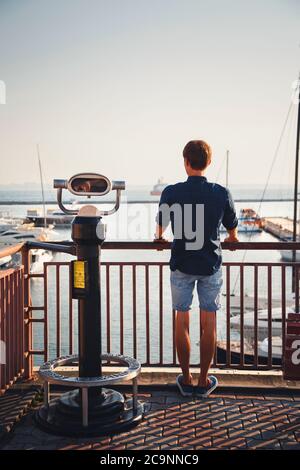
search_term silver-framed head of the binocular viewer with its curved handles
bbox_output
[53,173,125,215]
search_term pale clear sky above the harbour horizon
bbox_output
[0,0,300,184]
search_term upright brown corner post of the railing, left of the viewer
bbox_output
[22,244,33,379]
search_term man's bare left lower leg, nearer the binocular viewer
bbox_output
[175,311,192,385]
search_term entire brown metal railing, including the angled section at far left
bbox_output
[0,242,300,388]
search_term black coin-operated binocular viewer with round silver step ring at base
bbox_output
[36,173,143,436]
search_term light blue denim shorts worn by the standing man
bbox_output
[171,268,223,312]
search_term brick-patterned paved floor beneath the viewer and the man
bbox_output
[0,387,300,450]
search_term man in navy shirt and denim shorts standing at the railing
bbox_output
[155,140,238,398]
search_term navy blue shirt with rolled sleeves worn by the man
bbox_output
[156,176,238,275]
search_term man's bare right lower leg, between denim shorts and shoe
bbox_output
[198,310,216,387]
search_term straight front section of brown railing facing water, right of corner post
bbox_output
[26,242,300,370]
